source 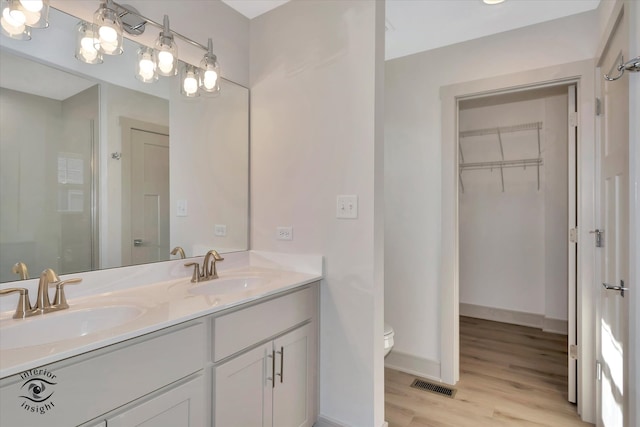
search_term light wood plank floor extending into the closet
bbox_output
[385,317,591,427]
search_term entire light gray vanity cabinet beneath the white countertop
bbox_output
[0,285,319,427]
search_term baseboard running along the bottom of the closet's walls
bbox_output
[460,303,568,335]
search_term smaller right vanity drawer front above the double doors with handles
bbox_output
[213,288,315,362]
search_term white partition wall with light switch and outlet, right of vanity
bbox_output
[251,0,384,426]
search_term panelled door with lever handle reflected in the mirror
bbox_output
[130,129,170,264]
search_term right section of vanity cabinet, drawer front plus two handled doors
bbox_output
[213,287,317,427]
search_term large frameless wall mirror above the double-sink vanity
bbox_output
[0,5,249,282]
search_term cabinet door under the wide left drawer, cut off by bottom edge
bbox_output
[107,376,205,427]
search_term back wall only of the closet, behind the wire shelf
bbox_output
[459,100,547,314]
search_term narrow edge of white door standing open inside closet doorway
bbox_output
[567,85,578,403]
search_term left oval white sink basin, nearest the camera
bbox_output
[0,306,143,350]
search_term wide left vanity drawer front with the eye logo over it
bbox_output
[0,322,206,427]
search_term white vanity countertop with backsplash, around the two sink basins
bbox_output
[0,253,322,378]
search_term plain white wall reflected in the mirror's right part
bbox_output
[169,81,249,257]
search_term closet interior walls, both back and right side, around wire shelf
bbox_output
[459,93,568,333]
